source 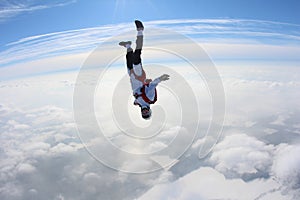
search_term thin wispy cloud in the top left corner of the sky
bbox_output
[0,0,76,23]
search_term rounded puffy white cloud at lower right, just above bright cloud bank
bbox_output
[209,134,274,179]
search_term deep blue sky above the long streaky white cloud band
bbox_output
[0,0,300,46]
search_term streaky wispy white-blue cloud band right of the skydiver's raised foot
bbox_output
[149,19,300,43]
